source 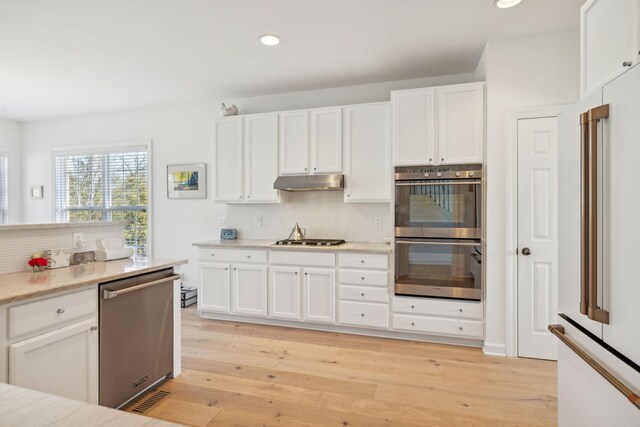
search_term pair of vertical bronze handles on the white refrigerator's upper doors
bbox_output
[583,104,609,324]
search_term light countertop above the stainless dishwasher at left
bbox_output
[0,258,187,304]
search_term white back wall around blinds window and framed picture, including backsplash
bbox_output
[23,74,473,285]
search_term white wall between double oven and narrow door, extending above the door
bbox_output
[478,31,580,353]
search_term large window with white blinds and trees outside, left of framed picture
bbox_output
[54,147,149,259]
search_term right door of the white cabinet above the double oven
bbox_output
[437,83,484,164]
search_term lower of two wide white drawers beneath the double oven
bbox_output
[393,314,484,338]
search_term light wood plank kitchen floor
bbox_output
[124,309,557,427]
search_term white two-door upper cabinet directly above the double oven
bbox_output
[391,83,484,166]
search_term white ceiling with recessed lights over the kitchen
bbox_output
[0,0,584,120]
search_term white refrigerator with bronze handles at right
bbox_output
[549,66,640,427]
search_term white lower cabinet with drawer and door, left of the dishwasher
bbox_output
[0,285,98,404]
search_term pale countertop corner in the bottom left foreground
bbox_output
[0,383,178,427]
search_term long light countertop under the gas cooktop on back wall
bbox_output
[193,240,391,254]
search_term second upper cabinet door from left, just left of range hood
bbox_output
[244,114,279,203]
